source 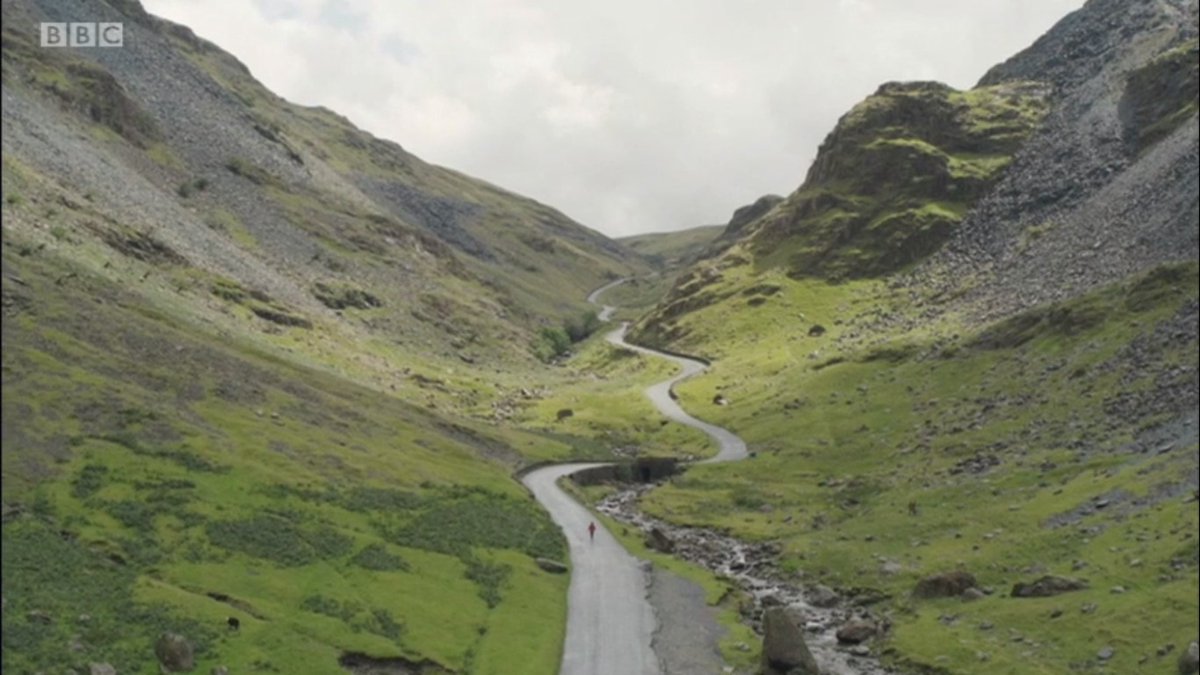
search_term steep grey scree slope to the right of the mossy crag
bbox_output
[913,0,1200,319]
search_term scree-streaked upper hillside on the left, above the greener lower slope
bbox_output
[4,1,642,367]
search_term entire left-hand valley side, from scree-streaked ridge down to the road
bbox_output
[0,0,648,674]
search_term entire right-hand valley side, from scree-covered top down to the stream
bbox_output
[619,0,1200,674]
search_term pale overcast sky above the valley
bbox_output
[144,0,1082,237]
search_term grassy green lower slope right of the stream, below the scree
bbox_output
[624,264,1200,674]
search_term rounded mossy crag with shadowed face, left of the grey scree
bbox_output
[724,82,1050,279]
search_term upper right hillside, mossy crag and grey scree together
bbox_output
[642,0,1200,340]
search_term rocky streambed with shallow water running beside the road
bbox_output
[596,485,893,675]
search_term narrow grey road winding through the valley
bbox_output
[522,279,746,675]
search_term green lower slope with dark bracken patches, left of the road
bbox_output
[4,239,580,674]
